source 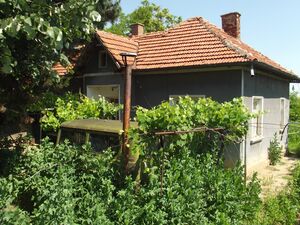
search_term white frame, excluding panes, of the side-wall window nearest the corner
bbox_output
[251,96,264,142]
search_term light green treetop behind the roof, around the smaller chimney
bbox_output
[107,0,182,35]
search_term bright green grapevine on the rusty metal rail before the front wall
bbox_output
[133,96,251,158]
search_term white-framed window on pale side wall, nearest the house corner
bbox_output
[252,96,264,139]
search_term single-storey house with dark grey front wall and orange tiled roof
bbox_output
[68,12,300,170]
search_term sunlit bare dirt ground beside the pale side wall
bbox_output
[253,156,299,198]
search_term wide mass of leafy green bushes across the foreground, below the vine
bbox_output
[0,140,259,224]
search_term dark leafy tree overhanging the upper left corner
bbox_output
[0,0,120,131]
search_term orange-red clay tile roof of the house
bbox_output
[97,17,291,78]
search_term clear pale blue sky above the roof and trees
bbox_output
[121,0,300,90]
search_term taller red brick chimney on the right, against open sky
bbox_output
[221,12,241,39]
